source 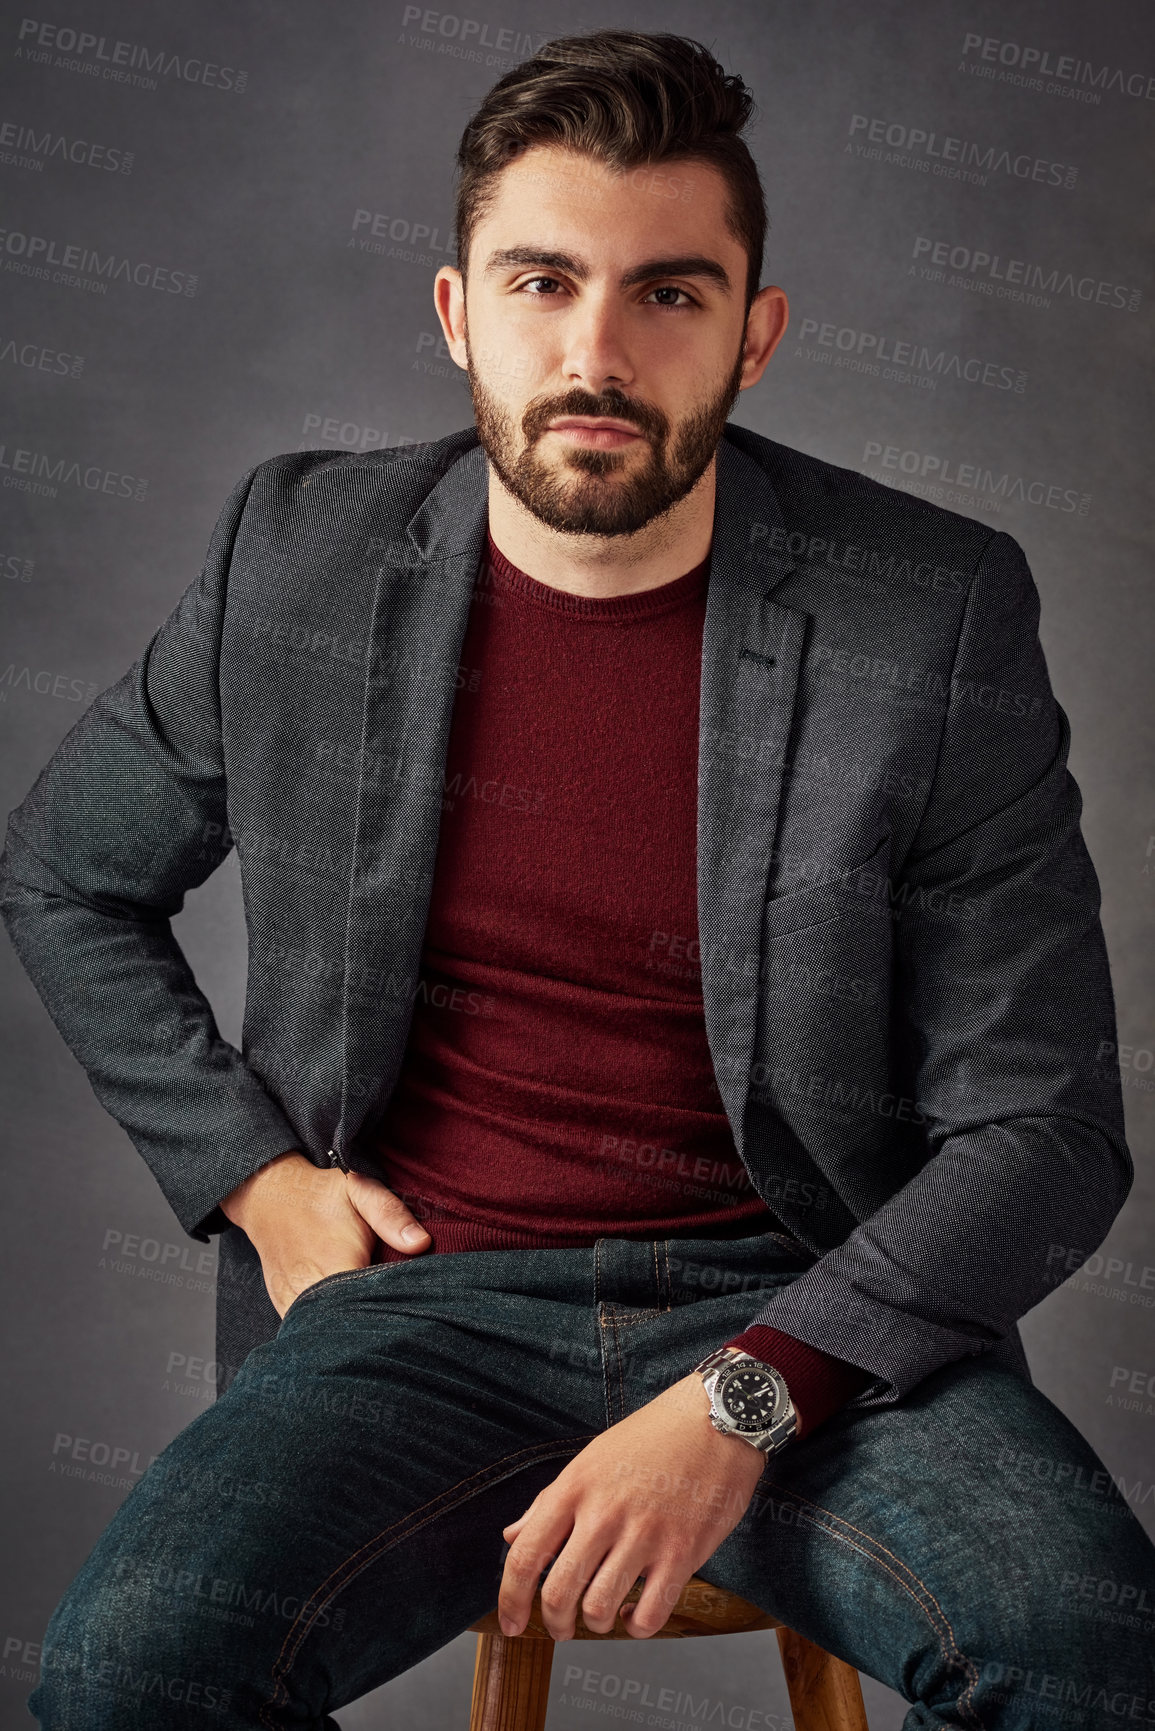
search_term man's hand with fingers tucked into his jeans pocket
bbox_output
[220,1149,433,1317]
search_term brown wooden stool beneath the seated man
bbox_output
[469,1575,869,1731]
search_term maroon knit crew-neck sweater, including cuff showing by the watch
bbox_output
[370,538,868,1432]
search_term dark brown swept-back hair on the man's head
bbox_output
[454,29,767,312]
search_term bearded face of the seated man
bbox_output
[438,145,779,535]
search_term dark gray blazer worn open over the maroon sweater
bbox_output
[0,424,1131,1406]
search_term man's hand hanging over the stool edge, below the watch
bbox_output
[497,1371,765,1641]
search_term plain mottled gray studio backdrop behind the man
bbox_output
[0,0,1155,1731]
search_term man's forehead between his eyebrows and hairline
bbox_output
[476,144,743,261]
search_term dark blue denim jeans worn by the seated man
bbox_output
[29,1234,1155,1731]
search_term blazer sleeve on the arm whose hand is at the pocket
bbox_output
[0,464,300,1241]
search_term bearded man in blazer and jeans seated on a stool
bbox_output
[3,31,1155,1728]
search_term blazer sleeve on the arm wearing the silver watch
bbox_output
[737,533,1132,1406]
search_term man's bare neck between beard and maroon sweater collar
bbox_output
[488,457,717,597]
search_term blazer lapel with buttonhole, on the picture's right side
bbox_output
[698,438,809,1158]
